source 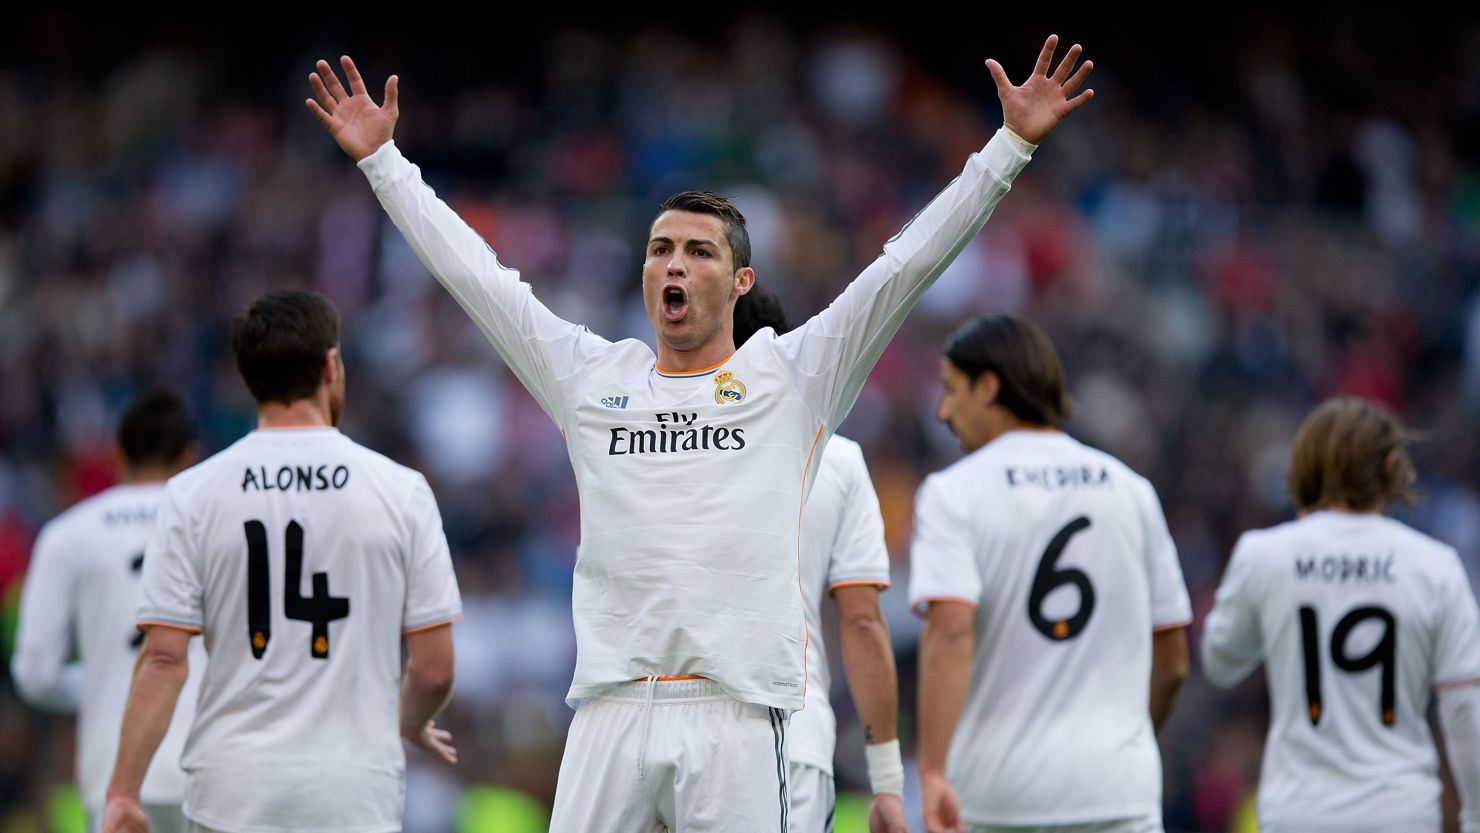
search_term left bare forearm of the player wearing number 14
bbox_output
[108,626,191,800]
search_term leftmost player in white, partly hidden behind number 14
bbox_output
[10,386,206,833]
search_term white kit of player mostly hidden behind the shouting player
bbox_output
[787,436,889,833]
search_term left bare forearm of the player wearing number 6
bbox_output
[919,602,977,778]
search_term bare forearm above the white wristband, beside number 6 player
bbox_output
[833,586,900,743]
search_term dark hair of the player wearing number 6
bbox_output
[946,314,1074,428]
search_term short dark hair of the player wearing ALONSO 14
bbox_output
[231,289,339,405]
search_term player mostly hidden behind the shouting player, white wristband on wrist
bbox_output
[734,286,909,833]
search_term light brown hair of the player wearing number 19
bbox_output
[1286,397,1418,512]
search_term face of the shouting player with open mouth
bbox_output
[642,212,753,352]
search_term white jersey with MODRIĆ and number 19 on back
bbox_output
[1202,512,1480,833]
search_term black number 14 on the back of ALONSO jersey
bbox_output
[243,521,349,660]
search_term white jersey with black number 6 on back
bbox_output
[910,431,1191,830]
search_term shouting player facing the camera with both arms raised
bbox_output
[306,38,1091,833]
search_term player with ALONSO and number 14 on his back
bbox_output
[105,290,462,833]
